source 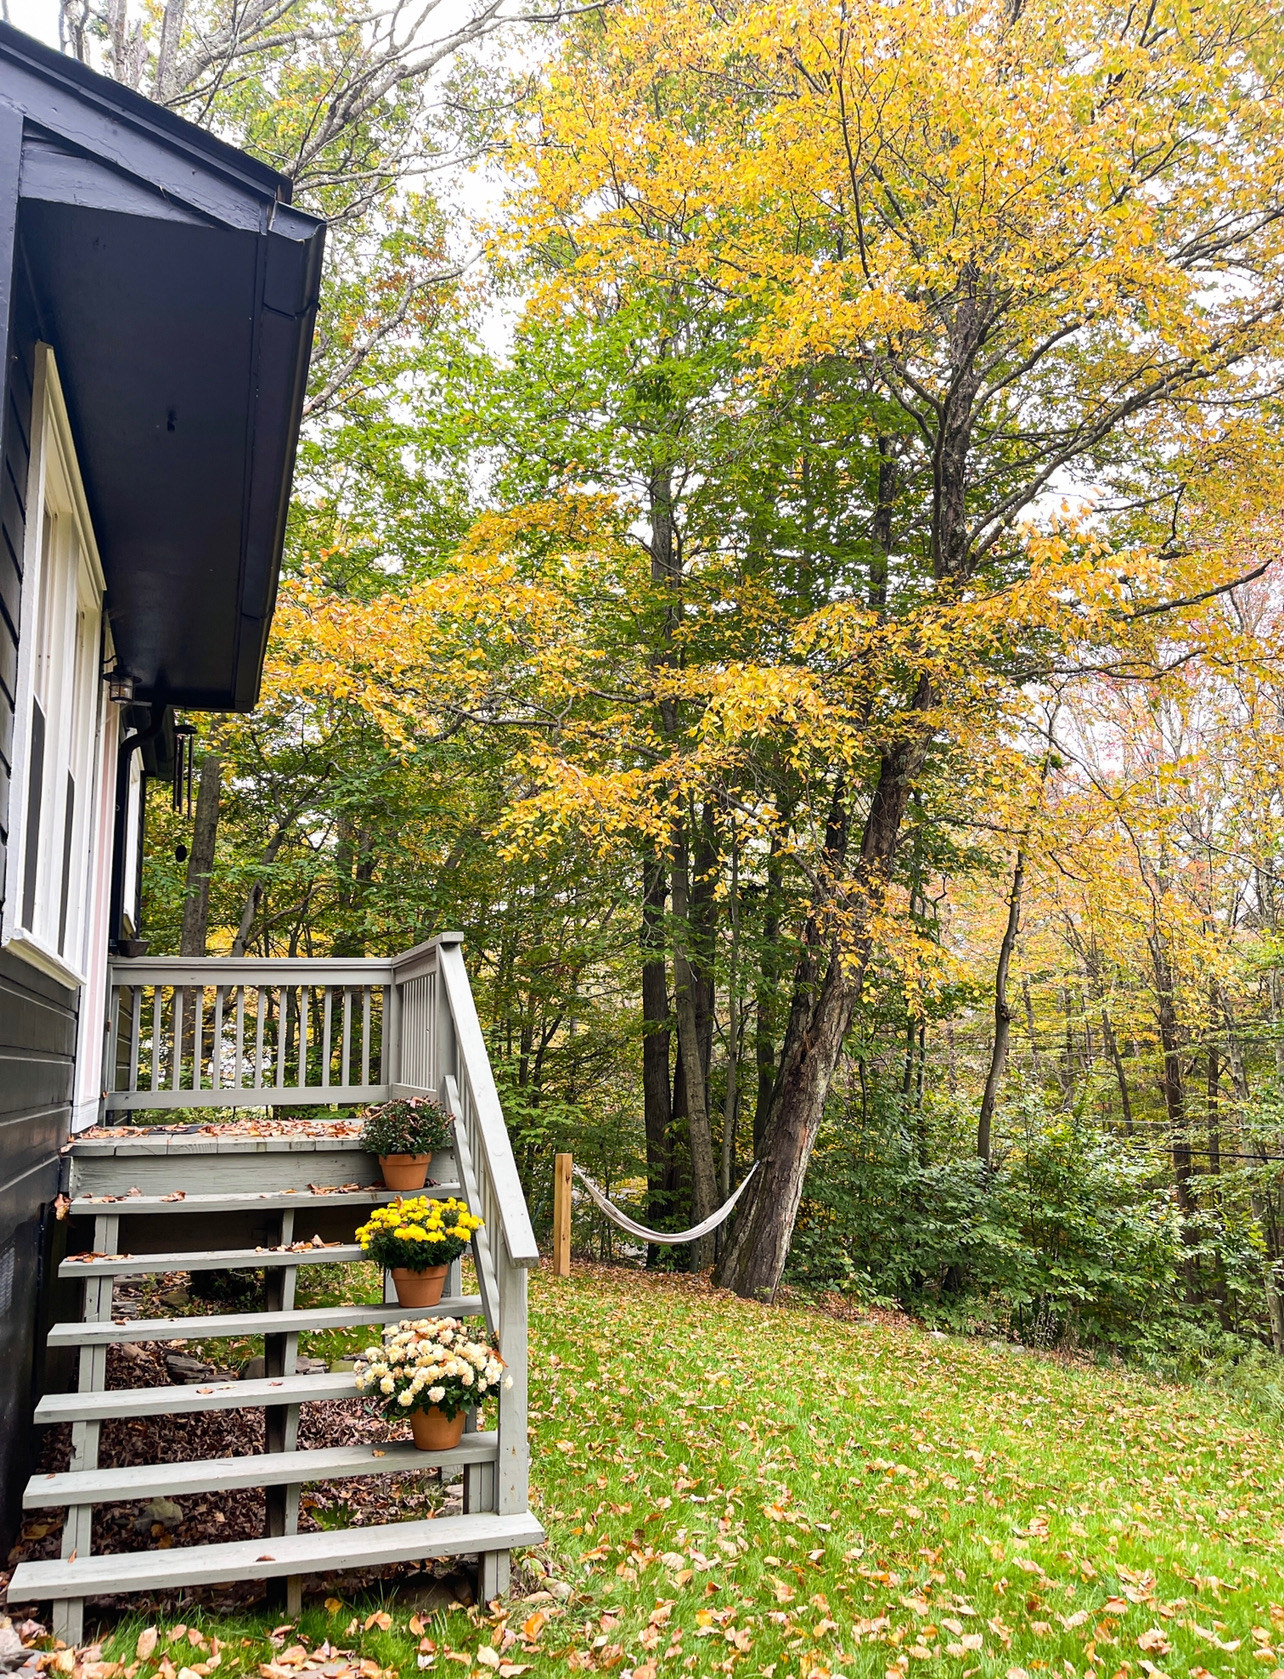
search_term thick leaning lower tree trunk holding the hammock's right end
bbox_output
[715,725,932,1300]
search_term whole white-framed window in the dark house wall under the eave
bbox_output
[5,346,102,984]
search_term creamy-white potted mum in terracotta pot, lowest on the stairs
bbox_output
[354,1318,512,1452]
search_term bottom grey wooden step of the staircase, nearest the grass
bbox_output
[8,1513,544,1603]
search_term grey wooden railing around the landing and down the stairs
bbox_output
[106,934,539,1593]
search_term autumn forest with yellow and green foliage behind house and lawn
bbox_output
[72,0,1284,1375]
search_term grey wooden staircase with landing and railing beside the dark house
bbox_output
[10,940,544,1644]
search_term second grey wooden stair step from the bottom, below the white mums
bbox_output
[22,1429,498,1509]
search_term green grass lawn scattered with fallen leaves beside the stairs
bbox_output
[85,1268,1284,1679]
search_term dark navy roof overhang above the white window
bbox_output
[0,25,324,710]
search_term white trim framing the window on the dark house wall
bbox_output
[0,344,116,989]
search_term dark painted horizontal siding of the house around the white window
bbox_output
[0,245,76,1556]
